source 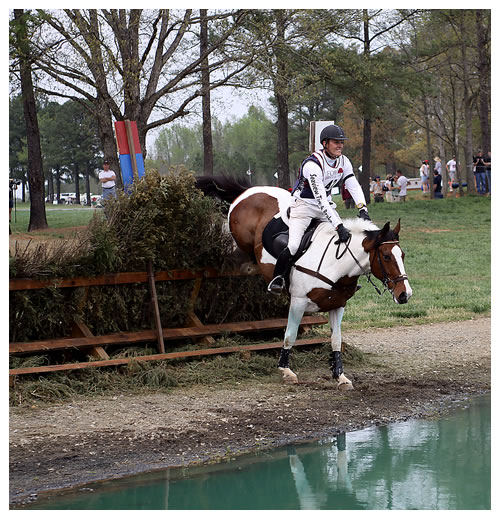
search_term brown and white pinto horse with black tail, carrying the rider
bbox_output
[193,177,412,390]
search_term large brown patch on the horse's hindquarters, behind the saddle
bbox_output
[229,193,279,259]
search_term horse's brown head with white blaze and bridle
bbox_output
[363,220,412,304]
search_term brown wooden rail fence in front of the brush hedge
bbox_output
[9,263,328,376]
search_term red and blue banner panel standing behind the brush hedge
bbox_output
[115,121,145,191]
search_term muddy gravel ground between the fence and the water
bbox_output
[9,318,491,505]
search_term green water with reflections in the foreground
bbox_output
[22,397,491,510]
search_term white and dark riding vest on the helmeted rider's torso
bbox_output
[292,151,354,199]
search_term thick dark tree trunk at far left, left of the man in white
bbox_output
[14,9,48,232]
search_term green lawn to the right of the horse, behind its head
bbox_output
[338,195,491,328]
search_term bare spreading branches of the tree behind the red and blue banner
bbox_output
[31,9,248,187]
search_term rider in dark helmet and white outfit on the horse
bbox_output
[267,124,370,294]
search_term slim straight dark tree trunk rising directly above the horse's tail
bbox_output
[200,9,214,175]
